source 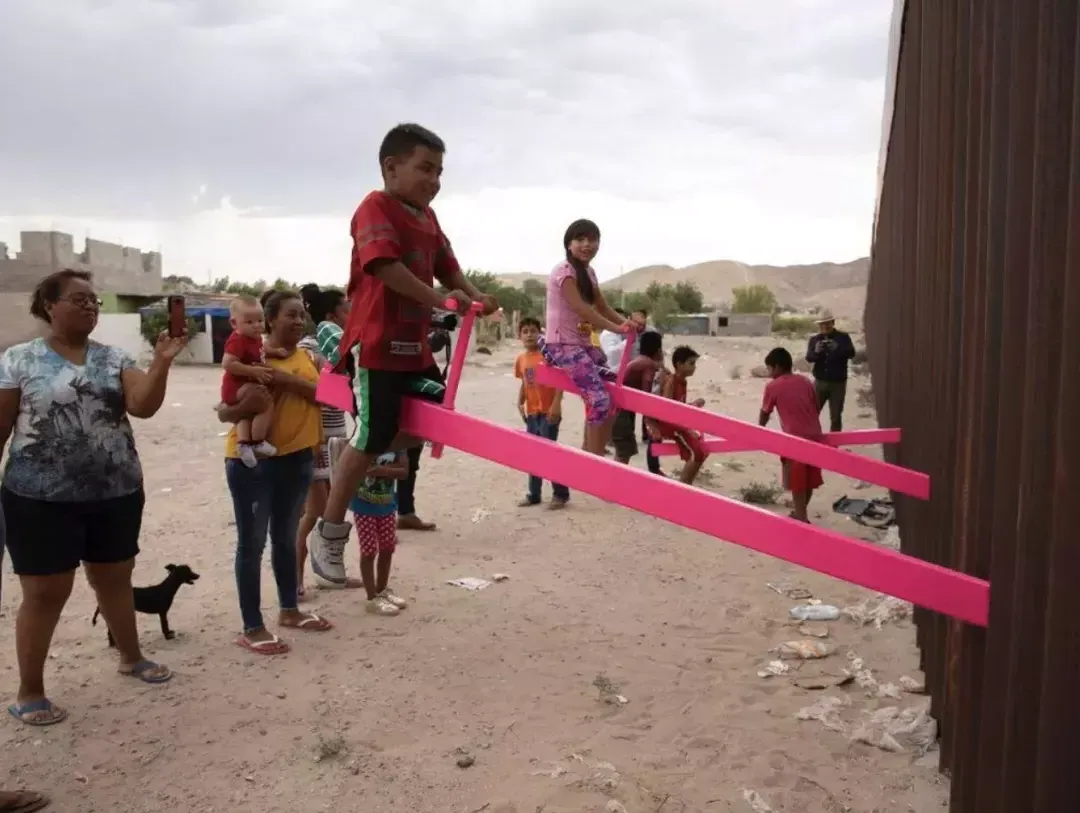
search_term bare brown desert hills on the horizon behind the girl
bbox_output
[500,257,869,320]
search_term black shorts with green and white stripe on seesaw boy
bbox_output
[349,354,446,455]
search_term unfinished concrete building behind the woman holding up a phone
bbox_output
[0,231,163,356]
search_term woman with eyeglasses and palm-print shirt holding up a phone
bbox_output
[0,270,187,726]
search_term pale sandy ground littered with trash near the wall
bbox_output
[0,339,947,813]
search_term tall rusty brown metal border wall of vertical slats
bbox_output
[865,0,1080,813]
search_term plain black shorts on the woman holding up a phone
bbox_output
[0,488,146,575]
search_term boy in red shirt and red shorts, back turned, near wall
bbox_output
[758,348,824,523]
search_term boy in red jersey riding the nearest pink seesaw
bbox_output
[308,124,499,587]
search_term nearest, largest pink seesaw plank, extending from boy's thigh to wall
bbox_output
[401,398,989,626]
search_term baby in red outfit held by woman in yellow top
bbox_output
[221,296,281,469]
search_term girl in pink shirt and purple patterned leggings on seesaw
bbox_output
[541,220,635,456]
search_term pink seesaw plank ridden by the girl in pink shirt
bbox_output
[536,366,930,500]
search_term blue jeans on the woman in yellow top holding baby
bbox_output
[225,449,315,633]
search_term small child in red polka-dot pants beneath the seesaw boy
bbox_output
[349,451,408,615]
